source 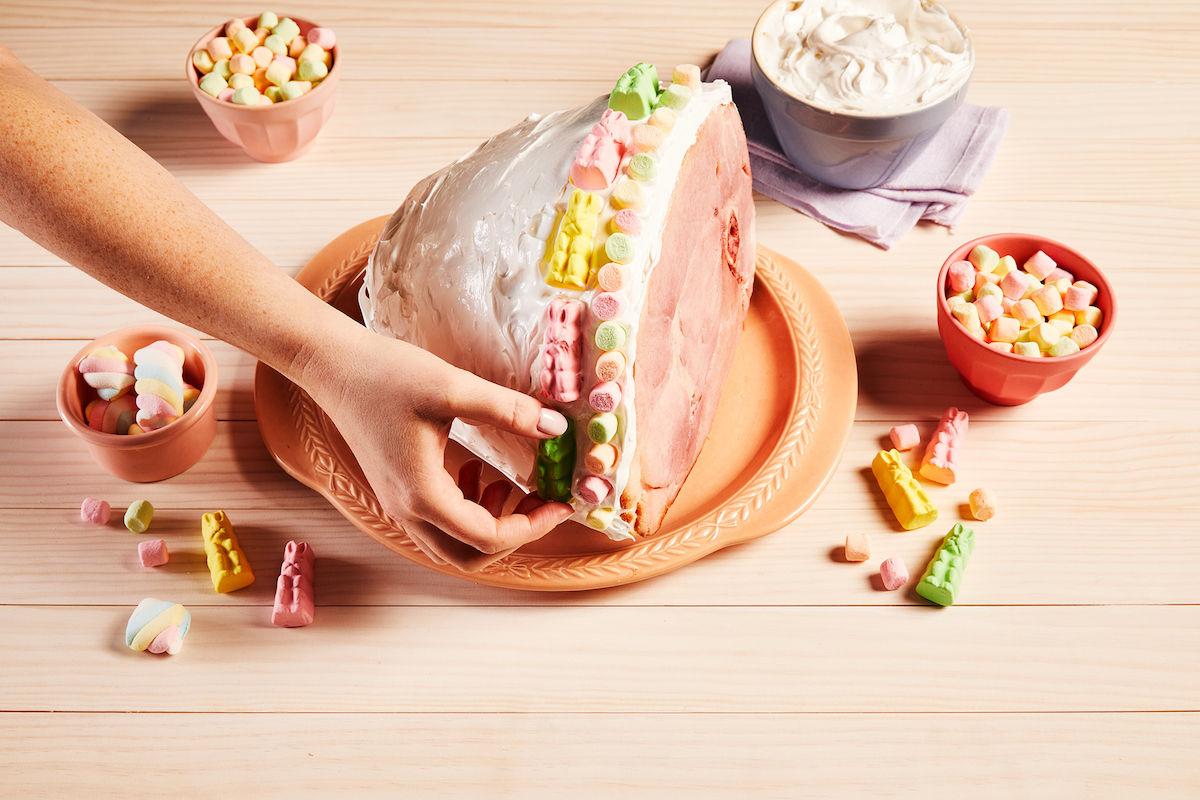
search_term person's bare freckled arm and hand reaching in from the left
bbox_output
[0,46,571,569]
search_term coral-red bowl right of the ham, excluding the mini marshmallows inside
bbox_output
[937,234,1117,405]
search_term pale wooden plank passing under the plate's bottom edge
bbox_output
[0,506,1200,606]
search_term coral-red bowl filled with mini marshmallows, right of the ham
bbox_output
[937,234,1117,405]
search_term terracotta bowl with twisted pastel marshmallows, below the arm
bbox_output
[56,325,217,482]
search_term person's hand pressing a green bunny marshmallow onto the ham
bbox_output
[298,330,572,572]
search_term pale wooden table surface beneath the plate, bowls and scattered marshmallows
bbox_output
[0,0,1200,798]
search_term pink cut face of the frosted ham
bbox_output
[622,106,755,535]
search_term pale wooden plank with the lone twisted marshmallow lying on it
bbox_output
[0,606,1200,715]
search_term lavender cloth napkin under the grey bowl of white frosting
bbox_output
[704,38,1008,249]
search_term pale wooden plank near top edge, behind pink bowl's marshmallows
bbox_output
[5,27,1200,83]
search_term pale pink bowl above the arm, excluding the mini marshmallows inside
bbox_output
[184,14,342,163]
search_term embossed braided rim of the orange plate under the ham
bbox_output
[256,219,857,590]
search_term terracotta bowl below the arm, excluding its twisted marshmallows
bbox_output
[56,325,217,483]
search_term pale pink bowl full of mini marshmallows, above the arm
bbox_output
[185,11,338,162]
